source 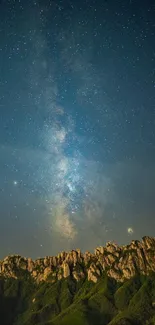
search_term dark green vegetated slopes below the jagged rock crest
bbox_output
[0,274,155,325]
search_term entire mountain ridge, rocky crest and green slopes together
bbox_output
[0,237,155,325]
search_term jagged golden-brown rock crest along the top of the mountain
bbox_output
[0,237,155,283]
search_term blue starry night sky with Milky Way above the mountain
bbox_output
[0,0,155,258]
